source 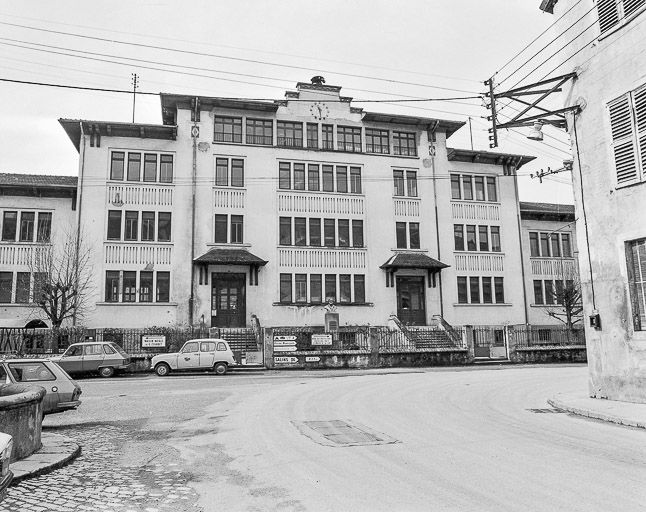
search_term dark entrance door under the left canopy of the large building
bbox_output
[211,273,246,327]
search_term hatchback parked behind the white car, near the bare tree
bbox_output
[52,341,130,377]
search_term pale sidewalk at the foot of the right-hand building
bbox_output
[547,393,646,429]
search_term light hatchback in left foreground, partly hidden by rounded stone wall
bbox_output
[0,359,81,414]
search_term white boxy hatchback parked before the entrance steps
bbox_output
[150,338,236,377]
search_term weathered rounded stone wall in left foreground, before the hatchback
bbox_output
[0,384,46,461]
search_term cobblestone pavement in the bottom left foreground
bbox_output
[0,424,202,512]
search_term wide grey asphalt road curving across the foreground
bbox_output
[14,366,646,512]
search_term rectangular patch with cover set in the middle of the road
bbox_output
[292,420,399,446]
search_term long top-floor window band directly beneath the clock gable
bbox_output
[213,116,417,156]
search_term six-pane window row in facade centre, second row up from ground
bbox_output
[279,217,364,247]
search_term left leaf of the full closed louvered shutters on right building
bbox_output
[608,94,637,185]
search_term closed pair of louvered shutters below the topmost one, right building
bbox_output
[608,87,646,187]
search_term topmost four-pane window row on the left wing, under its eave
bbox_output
[110,151,173,183]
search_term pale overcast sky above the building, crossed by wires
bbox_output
[0,0,572,203]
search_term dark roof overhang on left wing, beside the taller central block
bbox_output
[58,119,177,151]
